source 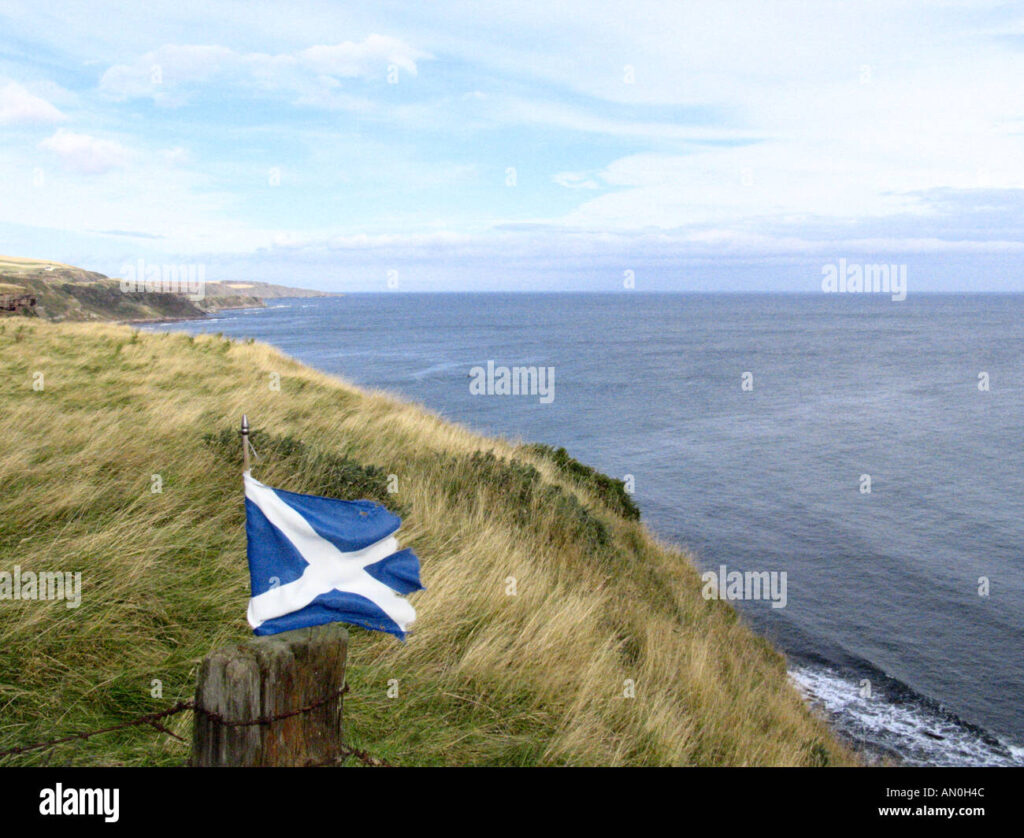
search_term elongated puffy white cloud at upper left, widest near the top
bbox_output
[99,35,431,104]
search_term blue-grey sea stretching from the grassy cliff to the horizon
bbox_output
[148,291,1024,765]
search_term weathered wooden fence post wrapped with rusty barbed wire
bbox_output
[191,623,348,766]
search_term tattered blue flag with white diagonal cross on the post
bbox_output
[245,471,423,639]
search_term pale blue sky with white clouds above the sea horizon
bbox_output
[0,0,1024,292]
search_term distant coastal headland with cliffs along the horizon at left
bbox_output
[0,256,332,322]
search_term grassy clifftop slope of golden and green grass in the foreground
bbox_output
[0,320,850,765]
